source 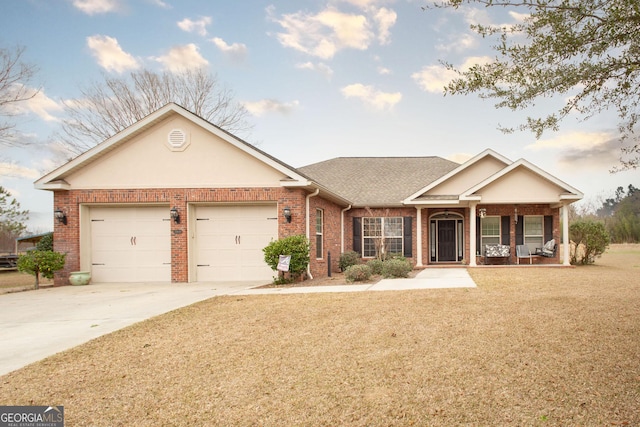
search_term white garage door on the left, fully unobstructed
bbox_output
[90,207,171,283]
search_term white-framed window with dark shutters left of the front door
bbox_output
[362,217,403,258]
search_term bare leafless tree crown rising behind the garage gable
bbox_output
[59,68,249,154]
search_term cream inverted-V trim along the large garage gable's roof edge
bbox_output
[34,103,310,190]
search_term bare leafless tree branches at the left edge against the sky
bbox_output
[0,46,38,146]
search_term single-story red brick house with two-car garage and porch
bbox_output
[35,104,582,285]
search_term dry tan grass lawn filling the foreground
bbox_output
[0,245,640,426]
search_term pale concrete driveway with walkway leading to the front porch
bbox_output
[0,268,476,375]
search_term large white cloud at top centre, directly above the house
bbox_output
[267,6,374,59]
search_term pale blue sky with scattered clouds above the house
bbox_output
[0,0,640,232]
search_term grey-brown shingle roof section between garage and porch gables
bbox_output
[298,157,460,206]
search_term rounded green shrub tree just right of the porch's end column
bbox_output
[569,219,610,264]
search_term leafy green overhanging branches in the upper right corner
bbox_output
[435,0,640,169]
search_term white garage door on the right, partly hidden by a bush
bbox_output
[194,205,278,282]
